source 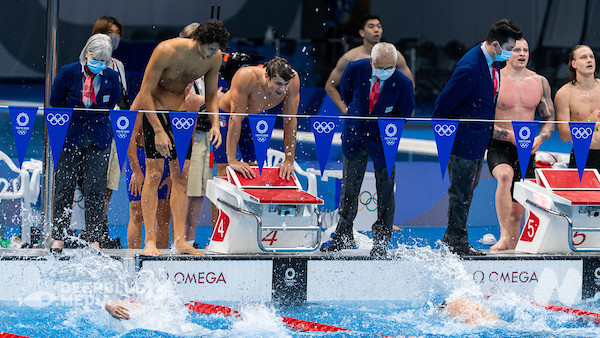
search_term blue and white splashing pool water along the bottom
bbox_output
[0,246,600,337]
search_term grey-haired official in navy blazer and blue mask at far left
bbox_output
[50,34,121,250]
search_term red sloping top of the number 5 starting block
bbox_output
[536,169,600,205]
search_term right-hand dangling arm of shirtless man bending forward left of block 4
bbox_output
[204,50,223,148]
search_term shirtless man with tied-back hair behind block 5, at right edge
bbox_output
[554,45,600,171]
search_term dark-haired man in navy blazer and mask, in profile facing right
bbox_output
[433,19,522,255]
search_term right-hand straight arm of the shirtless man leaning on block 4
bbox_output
[277,74,300,180]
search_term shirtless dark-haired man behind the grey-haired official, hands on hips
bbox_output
[325,14,414,113]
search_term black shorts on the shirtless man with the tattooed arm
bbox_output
[488,139,535,195]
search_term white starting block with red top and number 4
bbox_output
[206,167,323,254]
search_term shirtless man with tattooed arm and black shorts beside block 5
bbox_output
[488,39,555,251]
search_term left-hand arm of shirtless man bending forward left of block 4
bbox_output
[132,42,175,156]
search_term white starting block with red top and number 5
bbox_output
[514,169,600,254]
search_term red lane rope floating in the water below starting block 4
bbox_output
[185,301,390,337]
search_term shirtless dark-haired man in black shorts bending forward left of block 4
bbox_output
[130,20,229,255]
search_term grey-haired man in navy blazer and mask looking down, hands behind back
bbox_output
[321,42,414,258]
